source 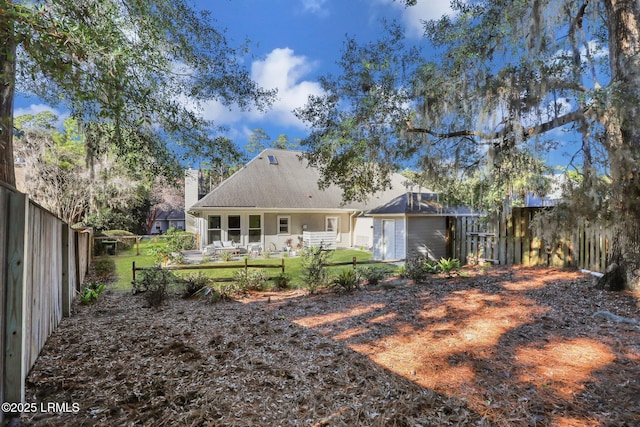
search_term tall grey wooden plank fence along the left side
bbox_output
[0,183,91,423]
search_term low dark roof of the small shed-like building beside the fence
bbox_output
[366,192,473,216]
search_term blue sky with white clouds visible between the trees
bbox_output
[15,0,576,169]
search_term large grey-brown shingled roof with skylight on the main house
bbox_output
[189,149,428,211]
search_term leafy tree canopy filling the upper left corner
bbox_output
[0,0,273,184]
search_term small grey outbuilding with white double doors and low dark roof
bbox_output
[366,192,474,260]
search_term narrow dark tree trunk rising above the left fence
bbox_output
[0,19,16,186]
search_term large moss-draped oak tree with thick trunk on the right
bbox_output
[298,0,640,290]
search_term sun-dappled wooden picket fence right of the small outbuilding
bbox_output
[448,208,611,272]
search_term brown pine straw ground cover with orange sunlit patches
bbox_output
[21,268,640,426]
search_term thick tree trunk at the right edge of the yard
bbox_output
[599,0,640,291]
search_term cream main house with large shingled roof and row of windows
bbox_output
[185,149,428,250]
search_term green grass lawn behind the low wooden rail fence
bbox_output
[105,239,393,290]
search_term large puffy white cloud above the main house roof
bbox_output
[205,48,322,129]
